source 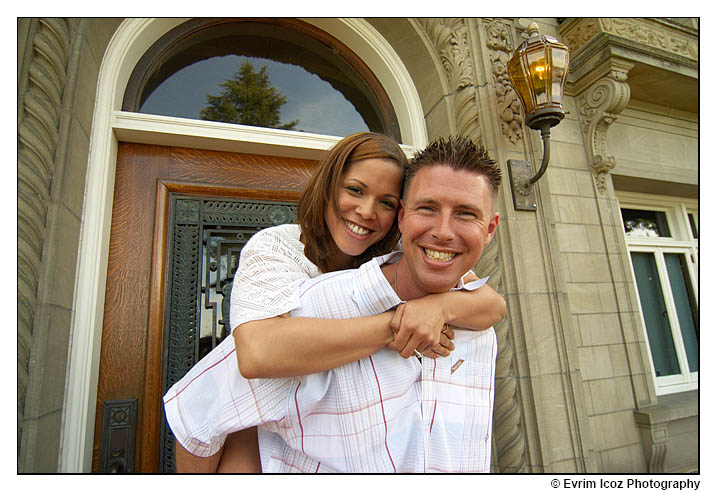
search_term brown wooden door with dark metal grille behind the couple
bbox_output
[93,143,316,472]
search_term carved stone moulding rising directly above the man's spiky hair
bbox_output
[418,18,482,144]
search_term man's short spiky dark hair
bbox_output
[404,136,501,199]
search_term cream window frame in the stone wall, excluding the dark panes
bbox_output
[616,192,700,396]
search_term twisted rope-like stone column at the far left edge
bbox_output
[17,19,71,456]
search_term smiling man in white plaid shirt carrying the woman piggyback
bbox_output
[165,135,500,472]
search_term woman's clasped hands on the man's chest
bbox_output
[387,296,454,358]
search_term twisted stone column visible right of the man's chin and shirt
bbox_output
[476,236,527,473]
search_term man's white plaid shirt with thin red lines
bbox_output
[164,253,496,472]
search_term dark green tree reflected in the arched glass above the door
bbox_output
[200,61,299,130]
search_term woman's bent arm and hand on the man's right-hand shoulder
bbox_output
[388,278,506,358]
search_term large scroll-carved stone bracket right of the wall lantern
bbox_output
[578,61,633,194]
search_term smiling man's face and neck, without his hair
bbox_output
[398,165,499,296]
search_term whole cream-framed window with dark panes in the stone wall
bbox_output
[618,194,699,395]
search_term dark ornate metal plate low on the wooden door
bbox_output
[100,398,137,474]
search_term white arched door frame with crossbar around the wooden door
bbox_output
[58,18,427,473]
